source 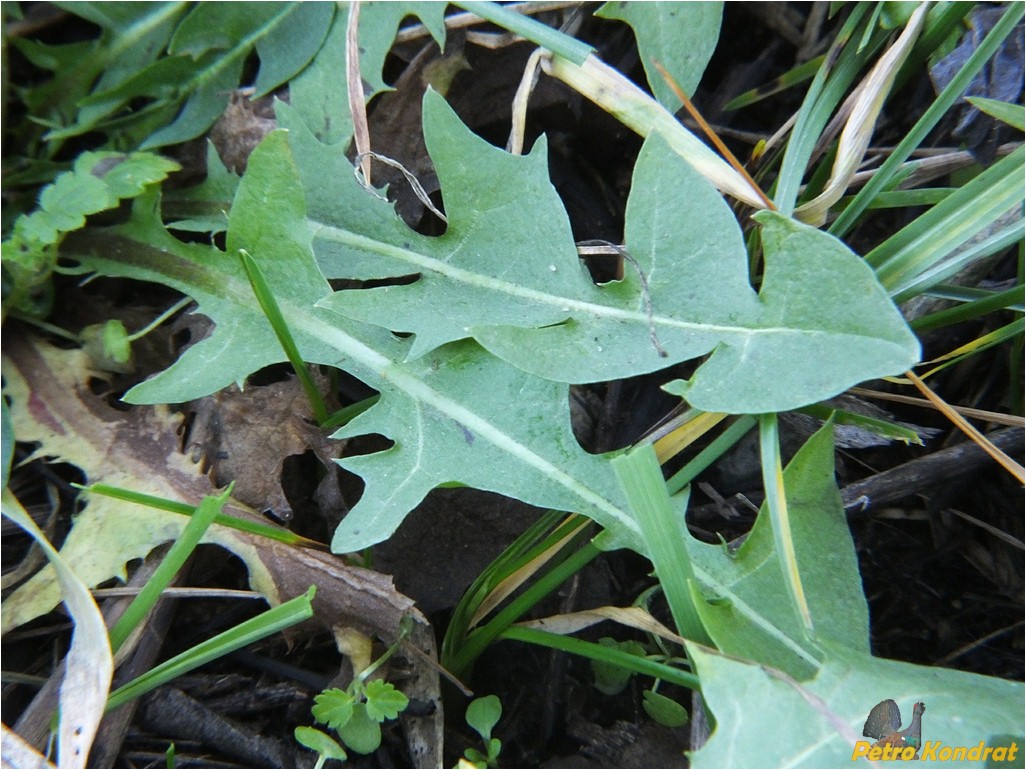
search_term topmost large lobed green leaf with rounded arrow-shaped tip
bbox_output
[307,92,918,413]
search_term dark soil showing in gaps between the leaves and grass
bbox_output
[3,3,1024,767]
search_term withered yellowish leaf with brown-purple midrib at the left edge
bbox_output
[3,335,424,640]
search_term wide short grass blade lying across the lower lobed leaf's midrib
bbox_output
[613,444,712,645]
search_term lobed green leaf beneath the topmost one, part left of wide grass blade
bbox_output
[67,131,637,552]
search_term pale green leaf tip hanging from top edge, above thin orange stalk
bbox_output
[595,2,723,105]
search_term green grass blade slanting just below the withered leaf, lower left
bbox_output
[107,586,315,711]
